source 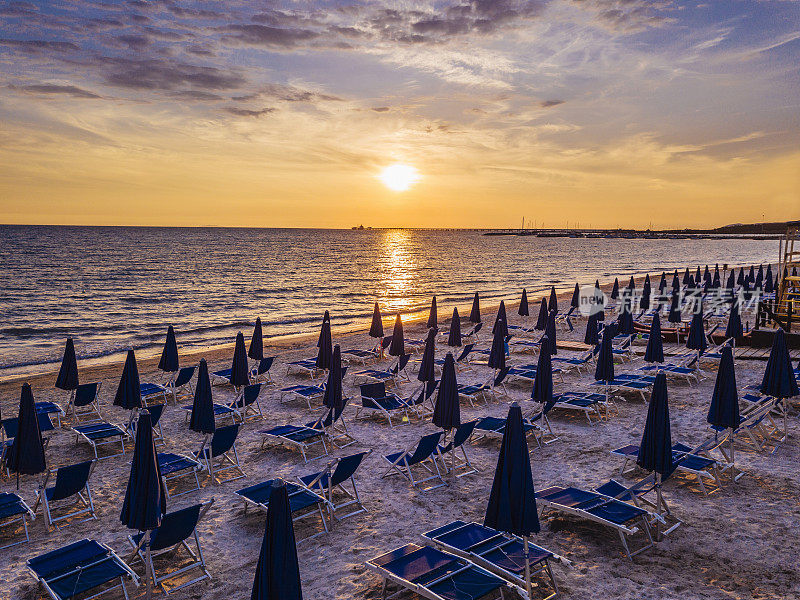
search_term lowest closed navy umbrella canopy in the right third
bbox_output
[636,373,674,478]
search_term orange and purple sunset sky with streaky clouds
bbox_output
[0,0,800,227]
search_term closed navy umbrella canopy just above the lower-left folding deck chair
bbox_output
[119,410,167,531]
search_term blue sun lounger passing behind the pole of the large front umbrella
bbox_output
[422,521,560,600]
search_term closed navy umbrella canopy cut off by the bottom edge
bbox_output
[250,480,303,600]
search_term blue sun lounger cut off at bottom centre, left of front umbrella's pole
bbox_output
[365,544,507,600]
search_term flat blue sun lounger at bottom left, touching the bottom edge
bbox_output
[27,538,139,600]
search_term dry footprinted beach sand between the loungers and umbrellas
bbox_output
[0,284,800,600]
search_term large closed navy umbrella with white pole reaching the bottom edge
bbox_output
[483,402,541,598]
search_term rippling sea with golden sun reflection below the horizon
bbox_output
[0,225,778,380]
